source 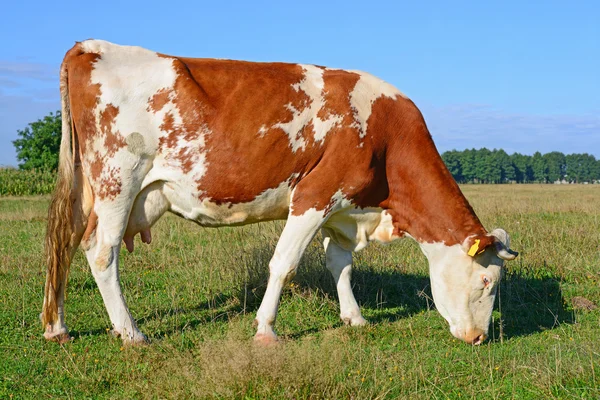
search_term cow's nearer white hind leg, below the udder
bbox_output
[82,203,147,344]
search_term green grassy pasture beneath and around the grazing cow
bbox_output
[0,185,600,399]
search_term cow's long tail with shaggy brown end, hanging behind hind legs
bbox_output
[42,57,75,327]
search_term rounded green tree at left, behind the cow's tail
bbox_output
[13,111,61,171]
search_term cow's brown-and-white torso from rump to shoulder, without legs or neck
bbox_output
[67,41,410,225]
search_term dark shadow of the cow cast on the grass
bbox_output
[138,244,575,340]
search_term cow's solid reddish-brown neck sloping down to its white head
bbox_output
[384,123,486,246]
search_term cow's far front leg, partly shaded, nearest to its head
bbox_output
[323,228,367,326]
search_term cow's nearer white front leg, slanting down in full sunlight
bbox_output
[254,209,325,344]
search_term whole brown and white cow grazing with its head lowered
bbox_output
[42,40,516,344]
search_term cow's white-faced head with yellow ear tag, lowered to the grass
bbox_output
[421,229,518,344]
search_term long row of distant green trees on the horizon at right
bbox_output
[442,148,600,183]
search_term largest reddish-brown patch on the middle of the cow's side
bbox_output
[176,59,322,204]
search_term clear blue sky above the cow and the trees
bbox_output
[0,0,600,165]
